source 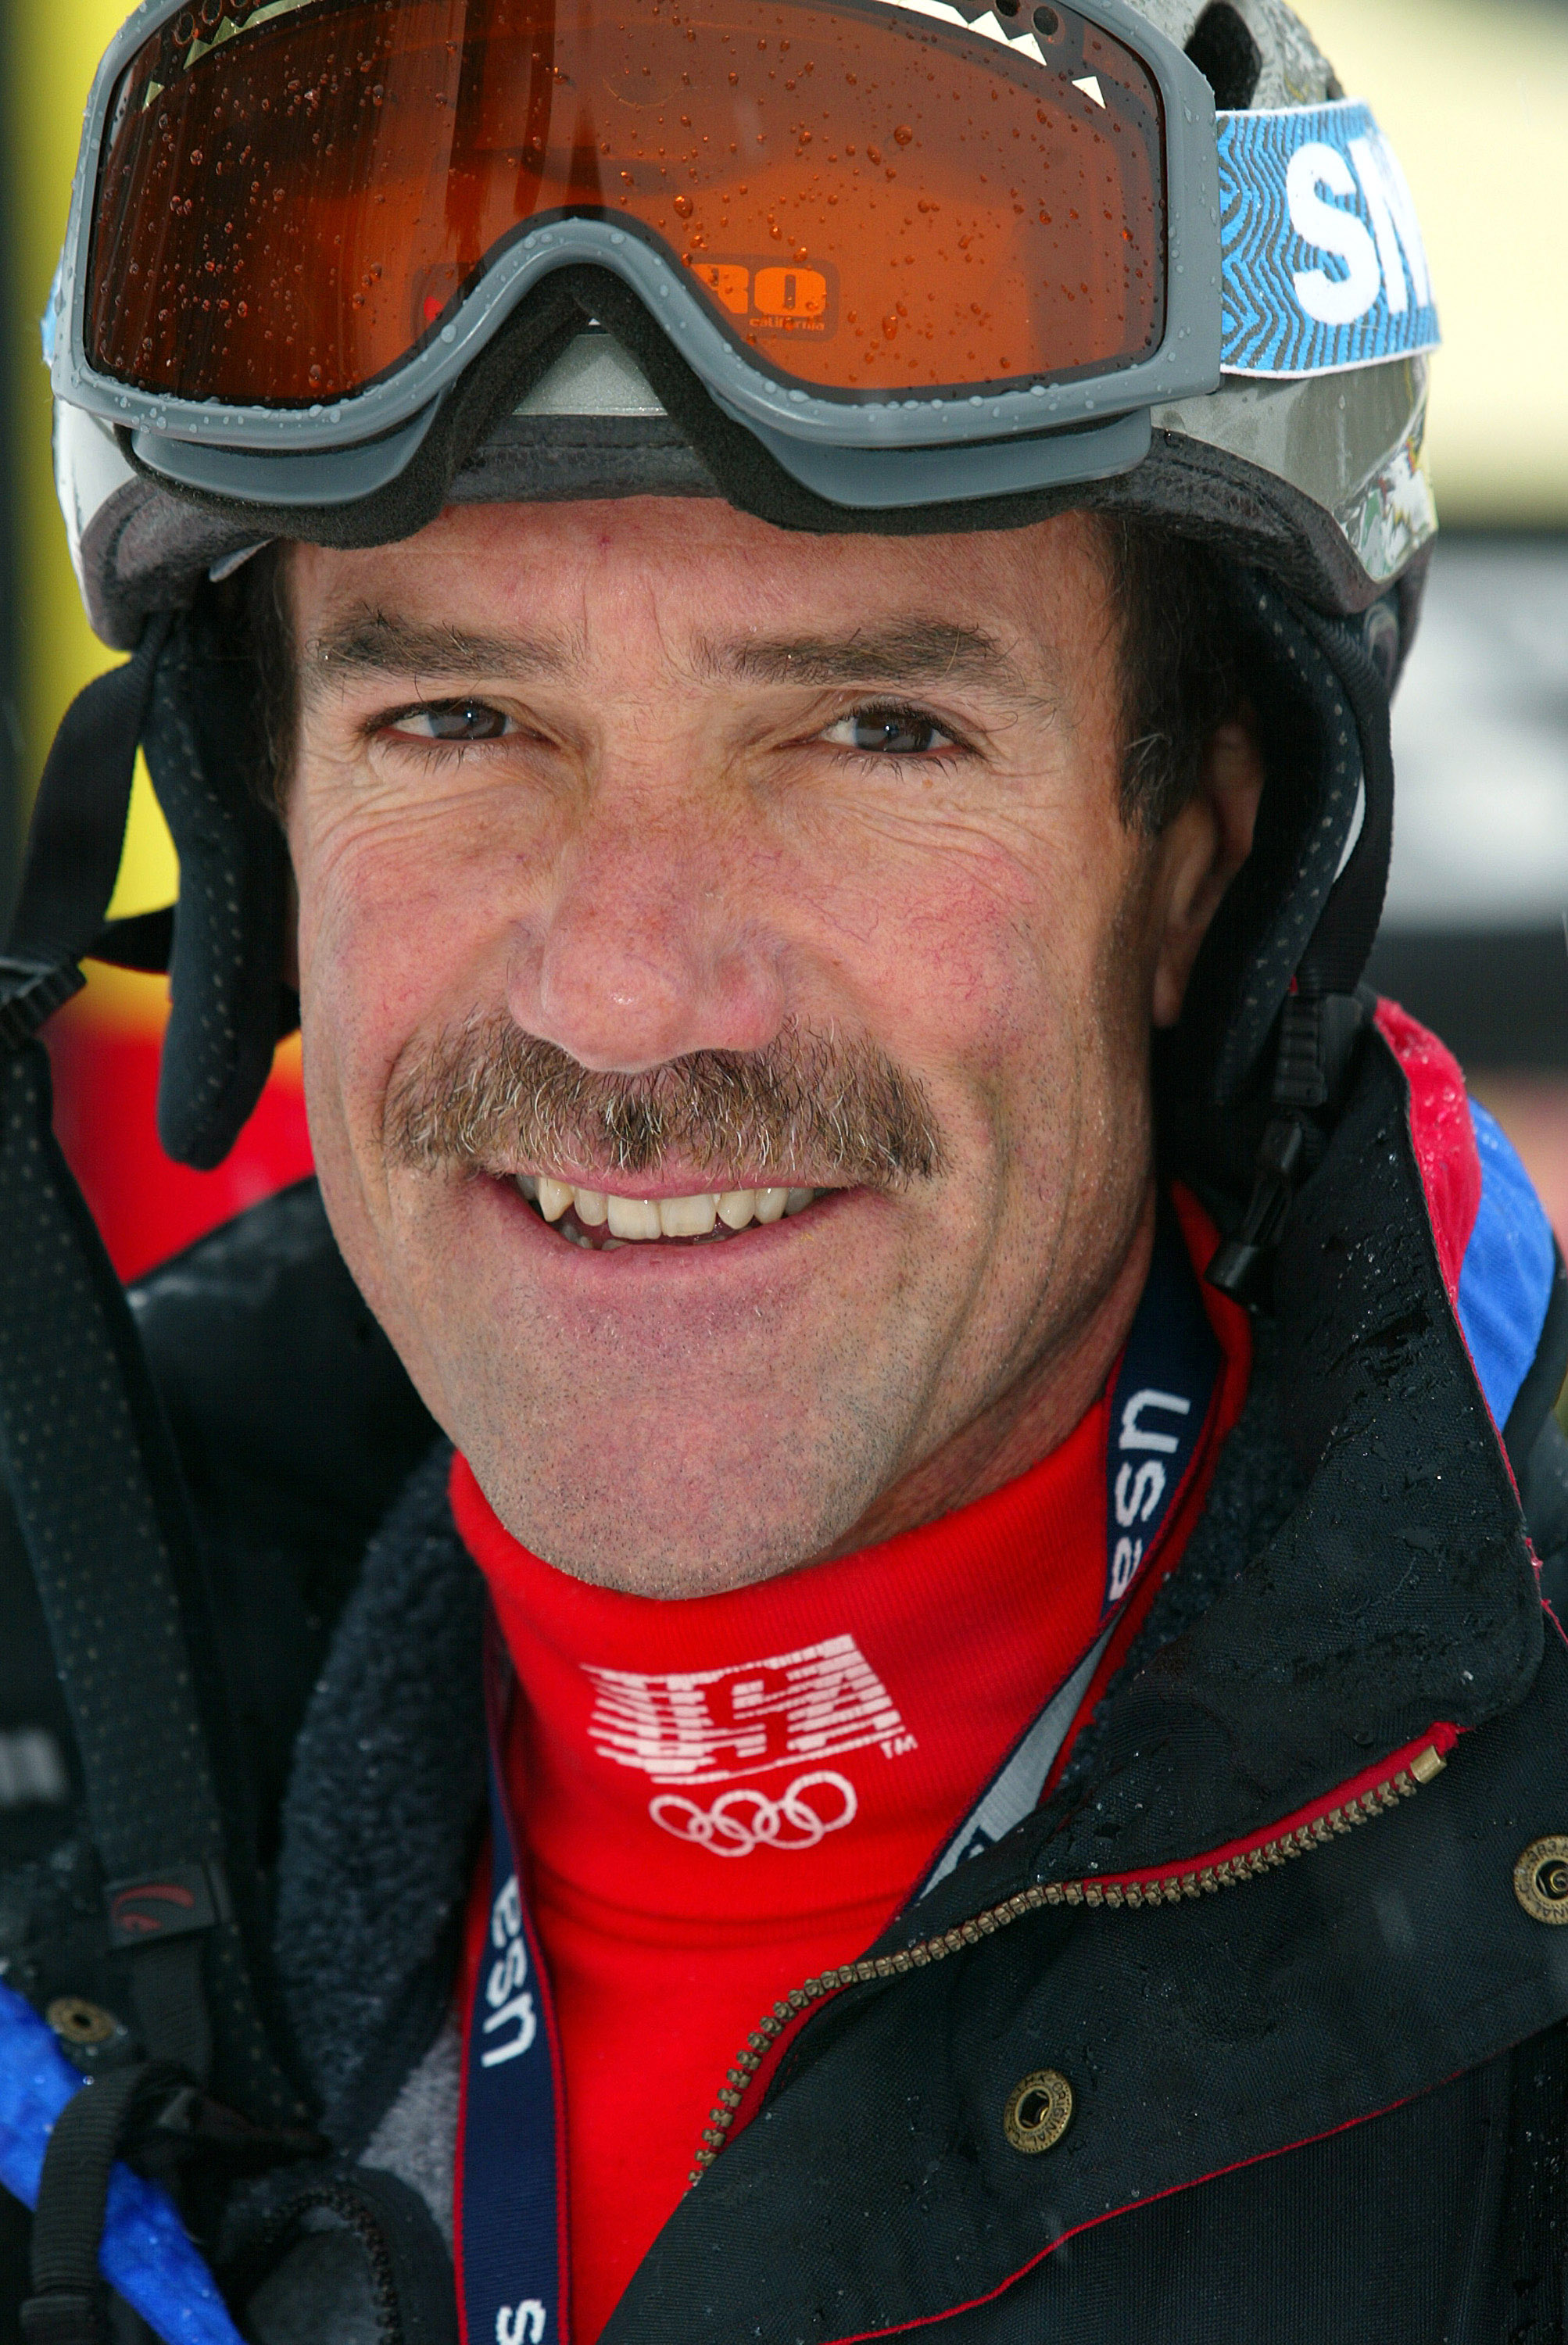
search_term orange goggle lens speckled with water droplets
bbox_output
[84,0,1165,406]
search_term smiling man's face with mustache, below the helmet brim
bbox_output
[288,499,1237,1595]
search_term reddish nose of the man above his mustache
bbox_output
[509,816,785,1074]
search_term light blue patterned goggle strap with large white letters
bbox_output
[1219,98,1441,378]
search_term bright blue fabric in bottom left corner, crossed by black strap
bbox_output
[0,1986,242,2345]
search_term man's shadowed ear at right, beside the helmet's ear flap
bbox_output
[1151,701,1263,1027]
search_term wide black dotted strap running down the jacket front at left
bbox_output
[0,1041,305,2125]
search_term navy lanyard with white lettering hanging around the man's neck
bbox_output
[457,1208,1223,2345]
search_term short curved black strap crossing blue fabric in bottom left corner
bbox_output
[21,2061,185,2345]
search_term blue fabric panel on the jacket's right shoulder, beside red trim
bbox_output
[1460,1100,1556,1426]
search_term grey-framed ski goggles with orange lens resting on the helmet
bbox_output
[54,0,1444,507]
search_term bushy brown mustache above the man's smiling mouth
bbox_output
[382,1013,942,1191]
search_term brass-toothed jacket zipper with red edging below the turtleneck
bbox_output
[687,1726,1458,2188]
